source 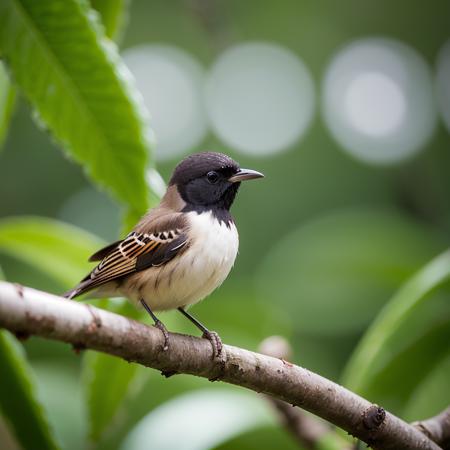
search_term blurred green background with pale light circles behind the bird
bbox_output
[0,0,450,450]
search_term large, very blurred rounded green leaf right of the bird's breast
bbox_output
[257,209,443,336]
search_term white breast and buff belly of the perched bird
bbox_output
[119,212,239,311]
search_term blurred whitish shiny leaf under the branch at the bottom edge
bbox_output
[120,389,274,450]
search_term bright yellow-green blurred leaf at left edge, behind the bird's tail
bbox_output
[0,216,105,288]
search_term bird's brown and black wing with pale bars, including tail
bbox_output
[65,214,188,298]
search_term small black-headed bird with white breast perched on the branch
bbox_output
[65,152,264,355]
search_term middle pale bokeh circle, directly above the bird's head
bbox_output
[206,42,315,155]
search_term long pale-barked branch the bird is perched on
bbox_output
[0,282,439,450]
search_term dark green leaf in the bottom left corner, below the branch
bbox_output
[0,330,58,450]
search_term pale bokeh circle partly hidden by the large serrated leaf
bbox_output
[123,45,208,160]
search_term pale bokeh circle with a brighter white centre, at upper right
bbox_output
[323,38,436,164]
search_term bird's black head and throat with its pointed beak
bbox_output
[169,152,263,212]
